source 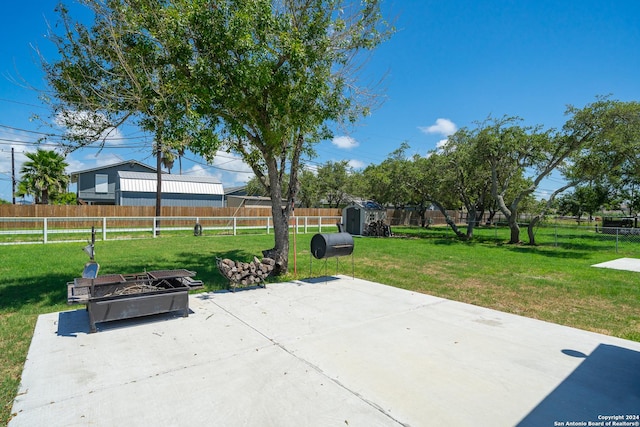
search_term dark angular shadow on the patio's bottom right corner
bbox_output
[518,344,640,427]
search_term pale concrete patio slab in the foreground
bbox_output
[9,276,640,427]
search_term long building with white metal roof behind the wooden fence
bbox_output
[115,171,224,207]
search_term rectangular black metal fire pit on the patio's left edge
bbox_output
[67,269,202,332]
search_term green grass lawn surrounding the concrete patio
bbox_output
[0,227,640,424]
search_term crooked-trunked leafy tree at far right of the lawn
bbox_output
[479,97,640,244]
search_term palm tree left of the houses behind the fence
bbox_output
[19,148,69,205]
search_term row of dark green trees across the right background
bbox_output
[249,97,640,244]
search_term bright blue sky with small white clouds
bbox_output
[0,0,640,200]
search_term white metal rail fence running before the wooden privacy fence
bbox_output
[0,216,342,244]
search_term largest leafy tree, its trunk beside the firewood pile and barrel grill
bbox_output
[47,0,390,272]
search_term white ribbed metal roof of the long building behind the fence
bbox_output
[118,171,224,195]
